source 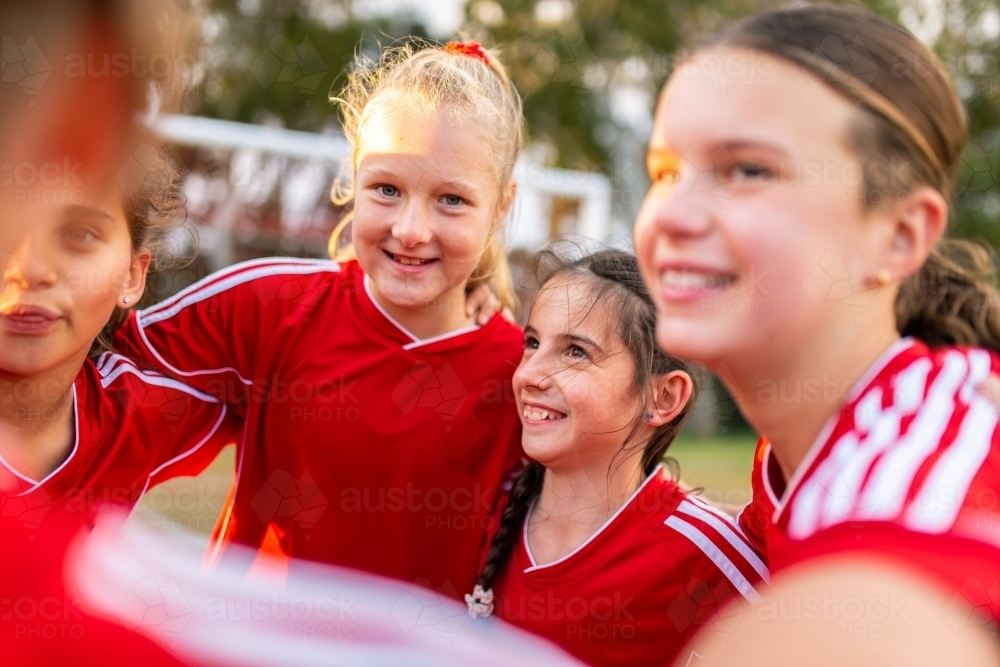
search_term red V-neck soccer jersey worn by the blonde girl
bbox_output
[118,258,523,597]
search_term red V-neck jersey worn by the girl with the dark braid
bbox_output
[493,467,767,666]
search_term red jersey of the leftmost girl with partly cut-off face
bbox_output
[0,353,239,528]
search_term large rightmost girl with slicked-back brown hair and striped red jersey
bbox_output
[635,6,1000,665]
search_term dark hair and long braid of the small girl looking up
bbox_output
[468,249,704,604]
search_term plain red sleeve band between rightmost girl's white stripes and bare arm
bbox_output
[774,514,1000,623]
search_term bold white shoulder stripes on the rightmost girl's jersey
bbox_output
[788,348,1000,539]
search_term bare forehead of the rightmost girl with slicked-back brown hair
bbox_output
[651,47,855,155]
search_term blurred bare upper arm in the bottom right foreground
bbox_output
[675,556,1000,667]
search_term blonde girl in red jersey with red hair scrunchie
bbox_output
[118,43,522,597]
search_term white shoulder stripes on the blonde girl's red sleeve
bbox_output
[139,258,340,327]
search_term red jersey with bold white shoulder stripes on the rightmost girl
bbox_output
[767,338,1000,621]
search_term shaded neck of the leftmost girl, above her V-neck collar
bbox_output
[0,359,83,480]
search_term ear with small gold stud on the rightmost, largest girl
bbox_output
[875,185,948,281]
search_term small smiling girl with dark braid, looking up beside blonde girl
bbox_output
[466,250,767,665]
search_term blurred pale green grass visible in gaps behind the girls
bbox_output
[133,433,756,535]
